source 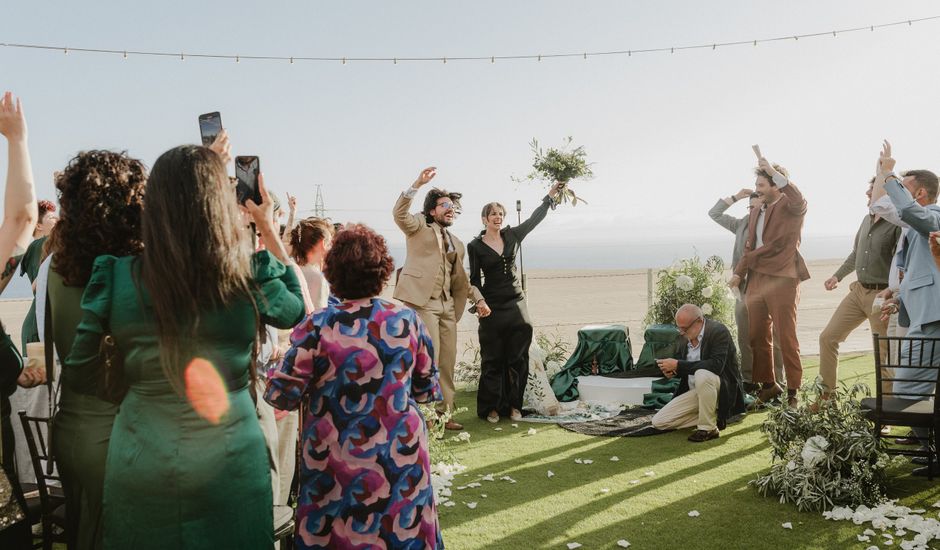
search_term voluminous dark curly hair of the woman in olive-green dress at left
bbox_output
[46,150,147,286]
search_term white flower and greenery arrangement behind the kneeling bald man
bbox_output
[644,256,735,333]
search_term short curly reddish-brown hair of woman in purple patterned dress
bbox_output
[323,224,395,300]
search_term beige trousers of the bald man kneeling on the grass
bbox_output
[652,369,721,432]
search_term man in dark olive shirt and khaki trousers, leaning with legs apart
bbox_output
[819,179,901,399]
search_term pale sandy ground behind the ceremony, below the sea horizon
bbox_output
[0,260,872,359]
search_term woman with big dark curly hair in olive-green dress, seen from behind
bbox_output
[49,151,147,550]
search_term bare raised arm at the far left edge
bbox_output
[0,92,39,264]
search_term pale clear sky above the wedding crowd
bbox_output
[0,0,940,267]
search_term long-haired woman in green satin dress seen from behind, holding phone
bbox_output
[66,146,304,550]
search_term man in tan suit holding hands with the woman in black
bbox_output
[392,167,490,430]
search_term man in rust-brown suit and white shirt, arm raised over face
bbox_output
[729,157,809,407]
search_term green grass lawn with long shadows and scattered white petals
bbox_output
[439,354,940,550]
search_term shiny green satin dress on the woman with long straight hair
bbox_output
[66,252,304,550]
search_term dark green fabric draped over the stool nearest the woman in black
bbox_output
[551,325,633,402]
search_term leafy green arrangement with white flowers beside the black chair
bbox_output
[751,383,889,512]
